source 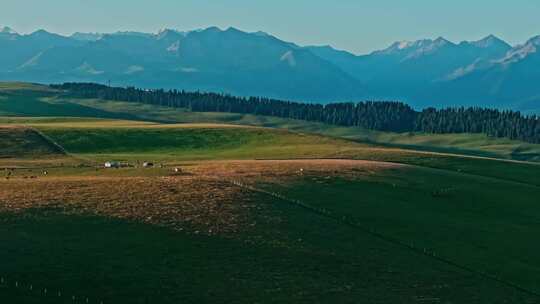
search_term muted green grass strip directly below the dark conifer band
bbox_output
[70,99,540,161]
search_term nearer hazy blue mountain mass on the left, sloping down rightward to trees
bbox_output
[0,27,367,101]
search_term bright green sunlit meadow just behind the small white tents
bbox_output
[17,121,364,161]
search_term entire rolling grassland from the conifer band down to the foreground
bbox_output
[0,84,540,303]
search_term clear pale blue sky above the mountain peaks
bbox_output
[0,0,540,53]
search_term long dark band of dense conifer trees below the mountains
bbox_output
[52,83,540,143]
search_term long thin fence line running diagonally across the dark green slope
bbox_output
[228,180,540,297]
